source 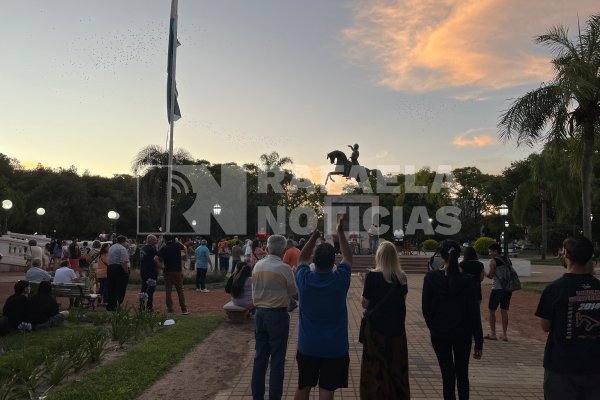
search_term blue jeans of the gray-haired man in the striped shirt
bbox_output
[252,307,290,400]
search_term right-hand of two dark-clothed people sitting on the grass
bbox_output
[27,281,69,329]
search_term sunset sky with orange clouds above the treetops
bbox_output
[0,0,600,183]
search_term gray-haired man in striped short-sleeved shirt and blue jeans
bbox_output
[252,235,297,400]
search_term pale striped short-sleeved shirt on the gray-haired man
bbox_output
[252,254,298,308]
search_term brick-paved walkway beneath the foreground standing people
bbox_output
[215,269,560,400]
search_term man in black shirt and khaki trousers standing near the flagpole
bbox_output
[156,235,190,315]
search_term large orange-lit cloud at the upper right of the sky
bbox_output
[343,0,596,92]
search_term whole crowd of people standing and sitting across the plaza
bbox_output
[3,230,600,400]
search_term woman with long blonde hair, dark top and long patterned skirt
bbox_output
[360,241,410,400]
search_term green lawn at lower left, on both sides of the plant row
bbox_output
[0,312,223,400]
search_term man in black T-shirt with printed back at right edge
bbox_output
[535,237,600,400]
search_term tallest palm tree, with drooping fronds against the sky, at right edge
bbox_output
[498,15,600,239]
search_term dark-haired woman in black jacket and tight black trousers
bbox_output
[422,240,483,400]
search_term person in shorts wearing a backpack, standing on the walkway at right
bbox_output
[485,243,512,342]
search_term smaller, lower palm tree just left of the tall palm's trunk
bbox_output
[512,149,579,260]
